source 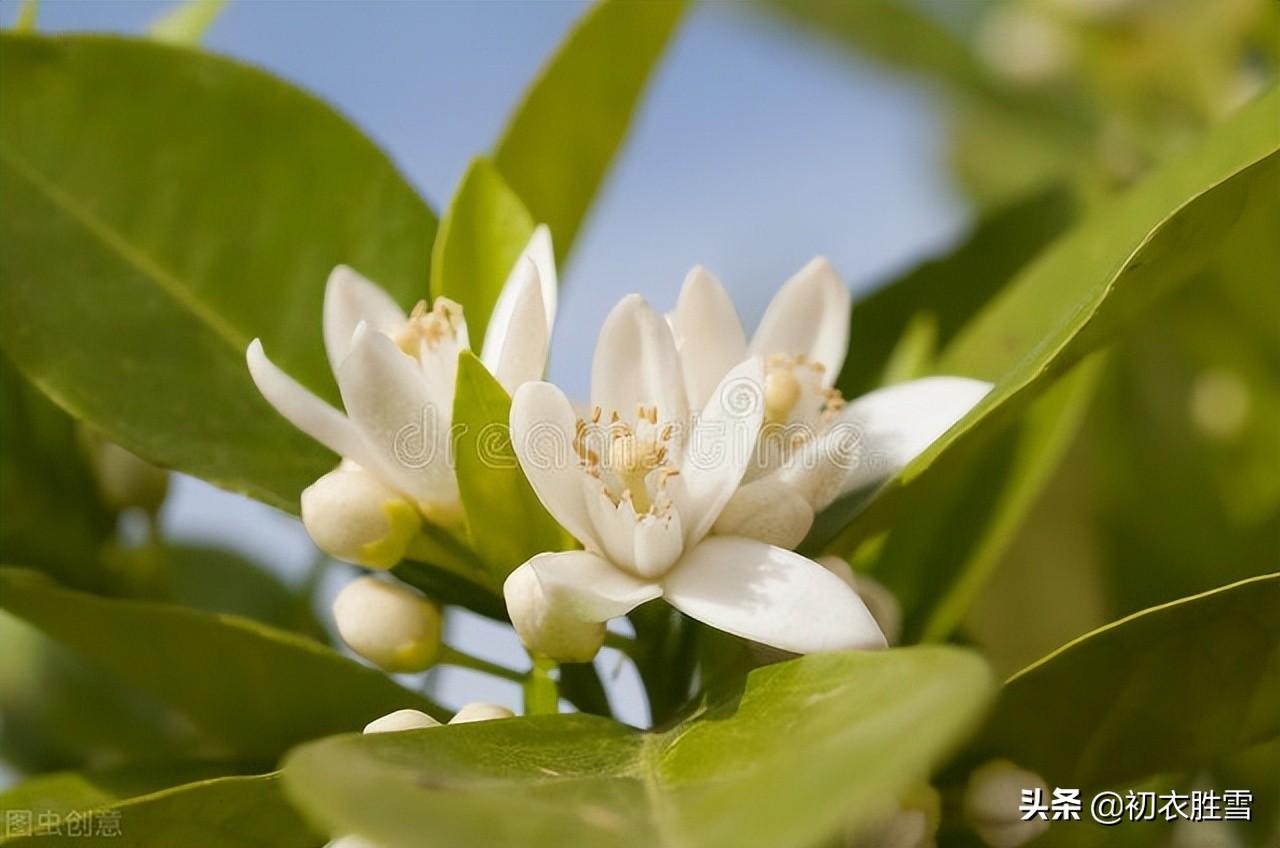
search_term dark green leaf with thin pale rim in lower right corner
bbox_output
[978,574,1280,790]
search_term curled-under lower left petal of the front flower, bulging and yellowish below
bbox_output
[502,551,662,662]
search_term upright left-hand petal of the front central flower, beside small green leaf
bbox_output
[511,383,603,550]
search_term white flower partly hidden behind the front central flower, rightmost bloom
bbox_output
[668,257,991,548]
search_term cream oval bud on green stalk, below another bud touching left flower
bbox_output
[333,576,440,673]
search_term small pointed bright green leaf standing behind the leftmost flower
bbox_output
[431,158,534,350]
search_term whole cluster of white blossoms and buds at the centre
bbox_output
[248,228,989,671]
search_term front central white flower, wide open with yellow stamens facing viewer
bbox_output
[504,295,884,661]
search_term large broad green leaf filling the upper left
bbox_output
[0,33,435,510]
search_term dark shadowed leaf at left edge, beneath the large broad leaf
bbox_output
[0,355,115,589]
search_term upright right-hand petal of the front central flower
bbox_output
[671,357,764,544]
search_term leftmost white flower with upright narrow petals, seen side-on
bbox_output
[246,227,556,555]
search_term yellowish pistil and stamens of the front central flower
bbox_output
[573,406,680,515]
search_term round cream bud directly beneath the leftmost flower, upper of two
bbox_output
[302,462,422,569]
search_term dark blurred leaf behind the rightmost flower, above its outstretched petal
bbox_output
[836,187,1075,397]
